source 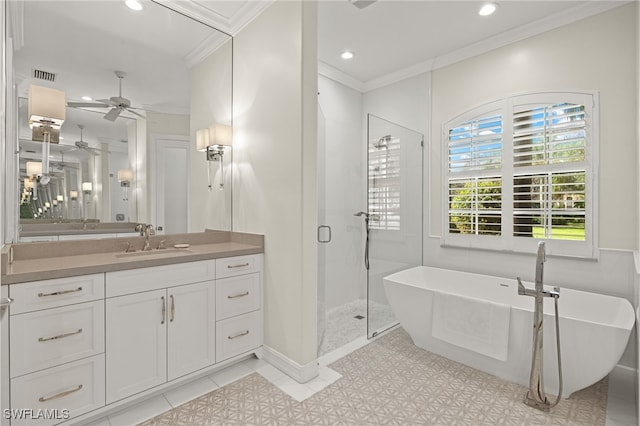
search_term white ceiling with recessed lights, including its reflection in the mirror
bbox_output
[8,0,627,151]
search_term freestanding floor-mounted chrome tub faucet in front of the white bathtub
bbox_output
[517,241,562,411]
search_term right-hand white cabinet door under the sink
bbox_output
[167,281,216,380]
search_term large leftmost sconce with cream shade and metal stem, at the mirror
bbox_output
[28,85,66,185]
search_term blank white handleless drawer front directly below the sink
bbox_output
[105,260,216,297]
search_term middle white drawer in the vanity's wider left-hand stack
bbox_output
[10,300,104,377]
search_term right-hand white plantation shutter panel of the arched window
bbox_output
[513,102,588,241]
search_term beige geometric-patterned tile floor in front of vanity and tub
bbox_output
[142,329,608,426]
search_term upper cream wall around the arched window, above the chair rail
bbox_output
[429,3,638,250]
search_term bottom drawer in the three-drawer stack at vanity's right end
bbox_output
[216,311,262,362]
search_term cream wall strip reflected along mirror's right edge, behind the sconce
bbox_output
[189,40,233,232]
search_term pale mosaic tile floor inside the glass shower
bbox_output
[318,299,397,356]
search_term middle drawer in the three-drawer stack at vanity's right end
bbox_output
[216,274,261,320]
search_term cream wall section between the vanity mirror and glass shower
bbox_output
[233,1,317,365]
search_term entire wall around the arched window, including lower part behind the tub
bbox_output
[423,3,639,367]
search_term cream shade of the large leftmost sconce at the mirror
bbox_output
[28,85,66,129]
